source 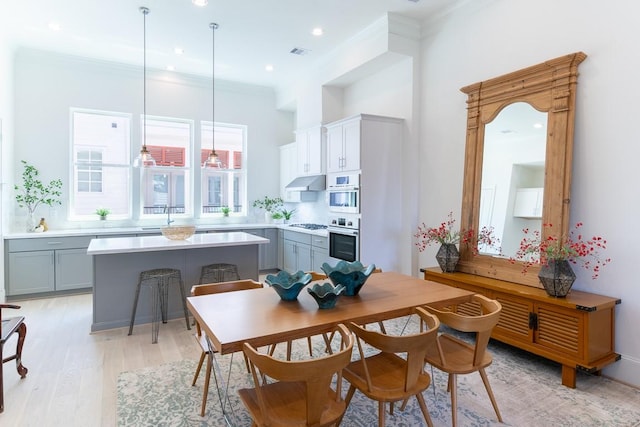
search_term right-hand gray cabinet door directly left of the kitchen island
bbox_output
[56,249,93,291]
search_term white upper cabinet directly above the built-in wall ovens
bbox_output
[327,117,362,172]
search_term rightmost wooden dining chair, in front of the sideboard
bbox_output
[425,294,502,427]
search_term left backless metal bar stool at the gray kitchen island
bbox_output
[129,268,191,344]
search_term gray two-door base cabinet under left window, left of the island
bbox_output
[5,236,94,296]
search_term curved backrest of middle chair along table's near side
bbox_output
[349,307,440,391]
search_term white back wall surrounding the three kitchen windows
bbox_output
[11,49,294,231]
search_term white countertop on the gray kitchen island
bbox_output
[87,232,269,255]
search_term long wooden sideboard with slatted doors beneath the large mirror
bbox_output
[420,267,621,388]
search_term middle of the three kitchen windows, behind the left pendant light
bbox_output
[141,117,193,217]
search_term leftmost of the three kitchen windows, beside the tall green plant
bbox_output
[69,109,131,219]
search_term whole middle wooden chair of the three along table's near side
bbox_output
[343,307,440,427]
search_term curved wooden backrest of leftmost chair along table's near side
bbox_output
[243,324,354,426]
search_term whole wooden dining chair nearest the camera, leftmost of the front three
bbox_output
[238,324,354,427]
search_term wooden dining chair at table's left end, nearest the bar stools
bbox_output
[191,280,262,417]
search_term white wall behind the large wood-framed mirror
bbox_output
[420,0,640,386]
